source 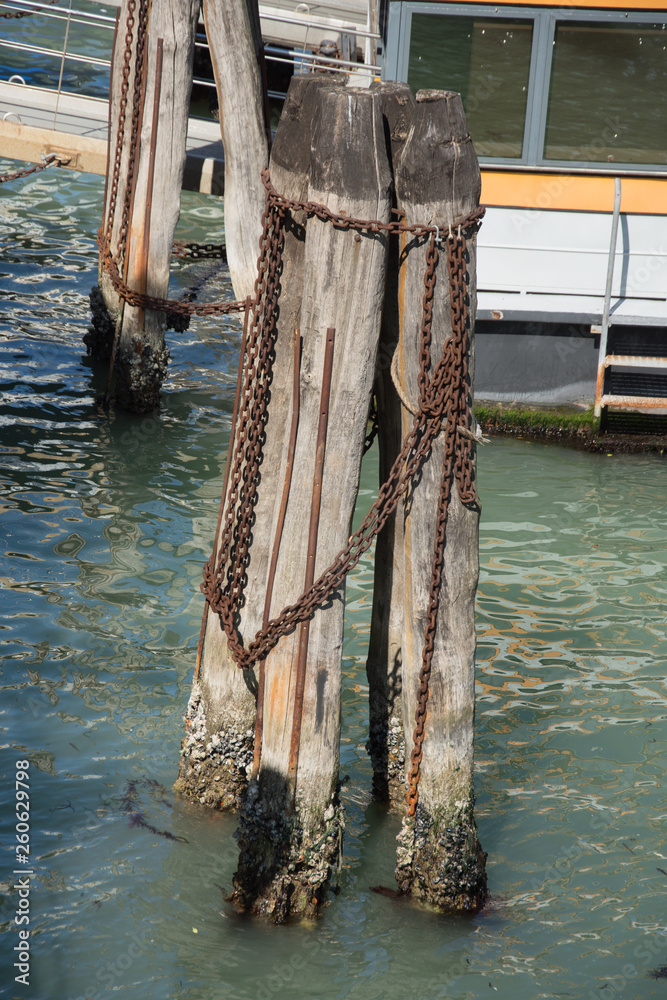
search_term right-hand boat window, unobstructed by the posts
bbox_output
[544,21,667,164]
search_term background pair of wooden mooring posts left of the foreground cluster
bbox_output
[89,0,268,413]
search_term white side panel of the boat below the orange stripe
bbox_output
[477,207,667,327]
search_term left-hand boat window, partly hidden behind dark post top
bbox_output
[408,13,533,159]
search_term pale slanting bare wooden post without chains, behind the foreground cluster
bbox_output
[202,0,269,299]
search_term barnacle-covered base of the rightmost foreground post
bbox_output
[395,801,488,915]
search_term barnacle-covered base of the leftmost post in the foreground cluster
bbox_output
[174,683,254,811]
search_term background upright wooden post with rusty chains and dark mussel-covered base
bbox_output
[88,0,199,413]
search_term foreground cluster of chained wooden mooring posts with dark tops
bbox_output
[177,76,486,922]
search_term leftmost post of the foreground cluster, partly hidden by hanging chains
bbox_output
[177,75,340,809]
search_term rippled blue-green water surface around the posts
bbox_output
[0,163,667,1000]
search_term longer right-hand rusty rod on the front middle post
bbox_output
[289,326,336,804]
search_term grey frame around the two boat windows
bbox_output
[382,0,667,175]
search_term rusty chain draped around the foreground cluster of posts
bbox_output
[196,171,484,815]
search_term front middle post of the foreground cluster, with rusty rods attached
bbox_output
[234,87,391,920]
